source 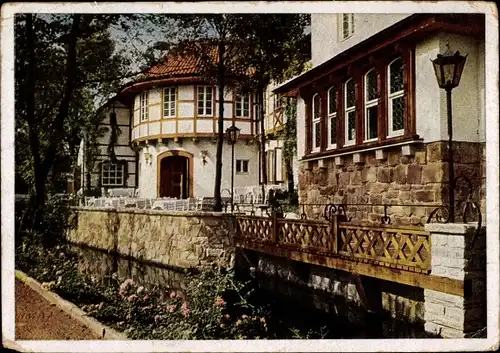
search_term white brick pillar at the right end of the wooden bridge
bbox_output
[424,224,487,338]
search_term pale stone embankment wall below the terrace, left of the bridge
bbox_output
[67,207,234,268]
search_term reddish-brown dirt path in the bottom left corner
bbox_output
[15,278,99,340]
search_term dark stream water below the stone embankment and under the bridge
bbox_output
[72,242,434,339]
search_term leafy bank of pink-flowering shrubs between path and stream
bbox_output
[16,242,340,339]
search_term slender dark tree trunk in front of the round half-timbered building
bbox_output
[214,40,226,212]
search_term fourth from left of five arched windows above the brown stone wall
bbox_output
[364,69,378,141]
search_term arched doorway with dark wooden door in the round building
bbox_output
[158,151,193,199]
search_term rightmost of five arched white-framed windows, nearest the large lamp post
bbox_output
[387,58,405,137]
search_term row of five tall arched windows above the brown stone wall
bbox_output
[307,49,415,153]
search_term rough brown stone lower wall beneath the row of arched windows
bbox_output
[299,141,486,225]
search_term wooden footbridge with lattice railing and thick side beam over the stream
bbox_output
[235,210,464,296]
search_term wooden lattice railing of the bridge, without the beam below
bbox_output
[236,213,431,273]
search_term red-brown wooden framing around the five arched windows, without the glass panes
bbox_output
[301,45,418,158]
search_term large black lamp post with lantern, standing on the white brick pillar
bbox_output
[431,44,467,222]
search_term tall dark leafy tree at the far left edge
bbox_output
[15,14,141,209]
